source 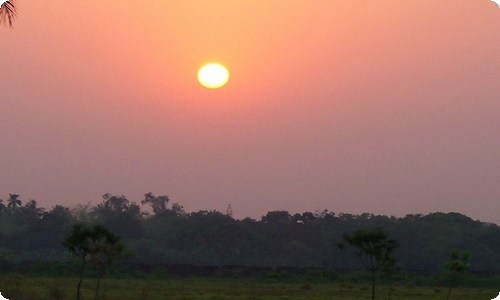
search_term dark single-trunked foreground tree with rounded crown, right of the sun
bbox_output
[338,229,399,300]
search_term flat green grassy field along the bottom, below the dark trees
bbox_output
[0,276,500,300]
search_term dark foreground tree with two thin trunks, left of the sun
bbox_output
[63,224,128,300]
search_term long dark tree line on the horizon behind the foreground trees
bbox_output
[0,193,500,272]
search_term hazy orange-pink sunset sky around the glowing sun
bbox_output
[0,0,500,223]
